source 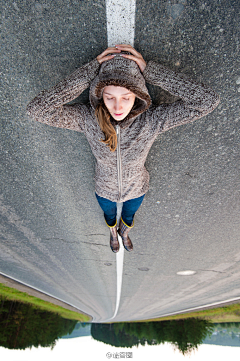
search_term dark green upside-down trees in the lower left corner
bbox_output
[0,298,77,350]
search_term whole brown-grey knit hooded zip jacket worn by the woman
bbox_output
[27,55,219,202]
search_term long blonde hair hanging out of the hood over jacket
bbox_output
[95,101,117,152]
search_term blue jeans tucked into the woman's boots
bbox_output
[95,193,145,227]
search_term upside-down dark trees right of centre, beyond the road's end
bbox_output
[91,318,213,355]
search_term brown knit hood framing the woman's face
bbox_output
[89,54,151,125]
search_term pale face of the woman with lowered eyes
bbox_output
[103,85,135,121]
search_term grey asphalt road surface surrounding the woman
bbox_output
[0,0,240,321]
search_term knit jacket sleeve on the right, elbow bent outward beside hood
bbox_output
[143,61,220,133]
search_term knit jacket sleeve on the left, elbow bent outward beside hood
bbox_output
[27,59,100,132]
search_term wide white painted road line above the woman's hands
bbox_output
[106,0,136,46]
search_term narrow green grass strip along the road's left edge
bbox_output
[0,283,91,322]
